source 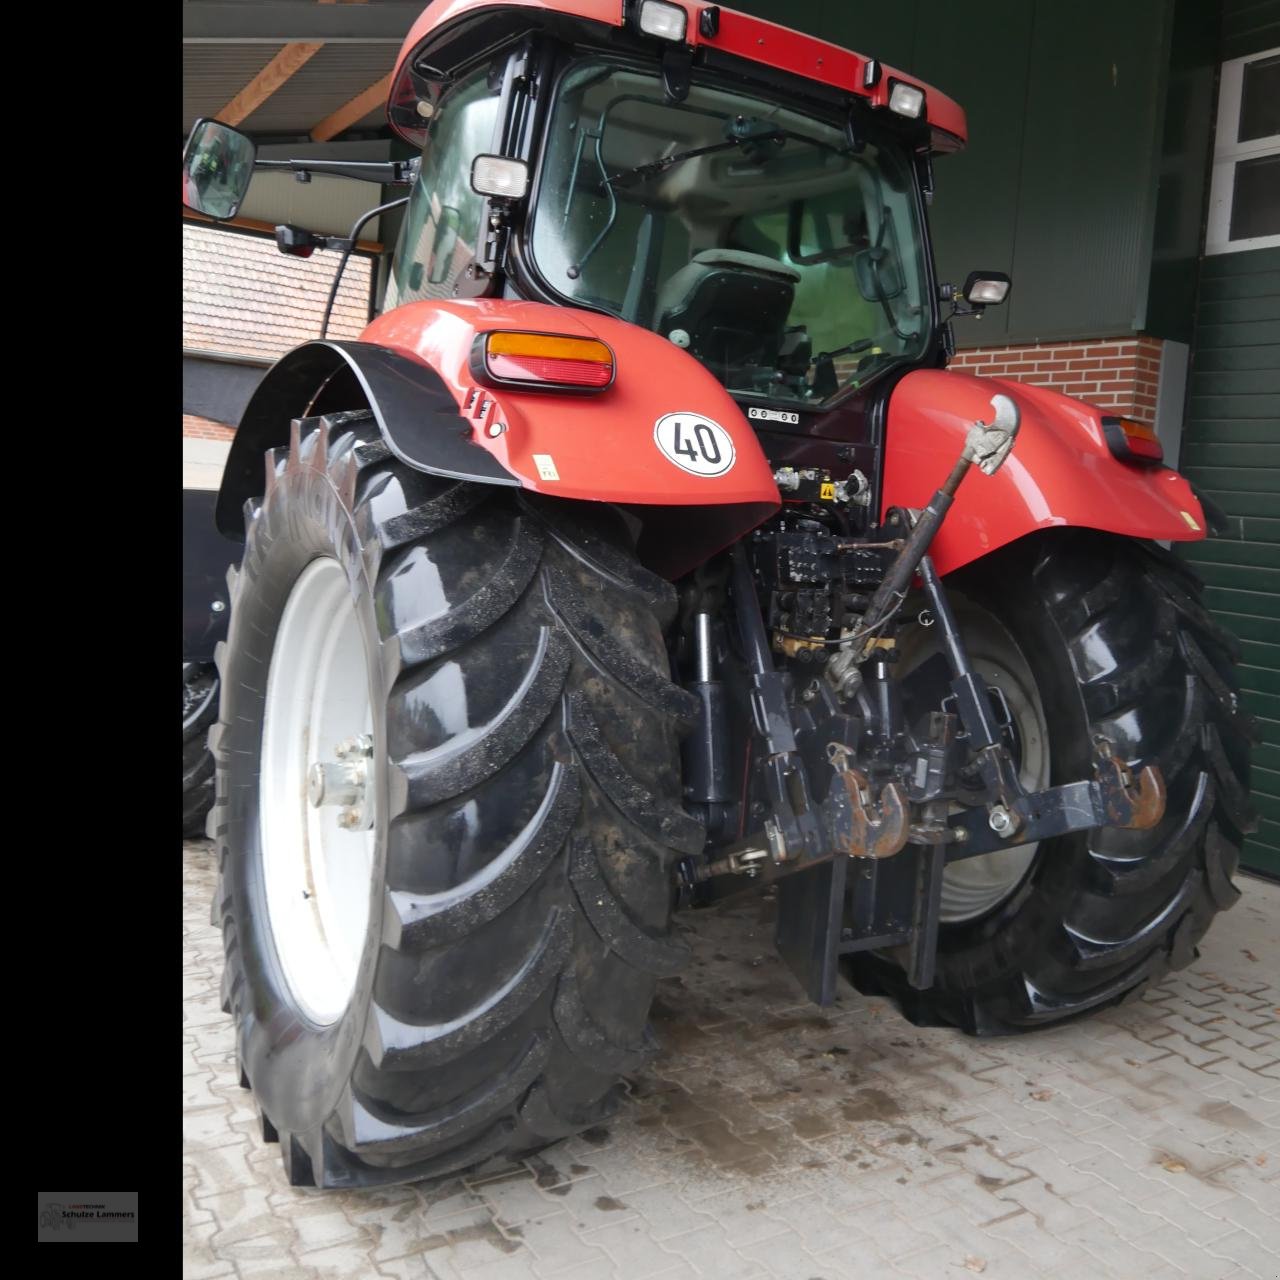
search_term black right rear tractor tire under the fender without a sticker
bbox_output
[849,530,1253,1034]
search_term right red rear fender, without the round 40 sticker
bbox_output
[883,369,1204,573]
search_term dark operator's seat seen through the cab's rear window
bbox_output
[655,248,800,367]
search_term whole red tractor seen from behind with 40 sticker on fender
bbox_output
[184,0,1252,1187]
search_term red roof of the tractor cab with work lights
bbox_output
[388,0,968,151]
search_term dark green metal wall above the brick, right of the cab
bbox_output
[740,0,1203,347]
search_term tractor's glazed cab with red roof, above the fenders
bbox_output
[387,0,963,408]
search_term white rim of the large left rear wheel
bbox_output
[259,557,376,1025]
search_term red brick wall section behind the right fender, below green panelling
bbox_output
[951,338,1162,424]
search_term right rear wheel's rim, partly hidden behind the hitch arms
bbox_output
[904,596,1050,924]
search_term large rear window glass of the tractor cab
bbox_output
[530,59,932,404]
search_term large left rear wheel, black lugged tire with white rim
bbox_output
[210,413,703,1187]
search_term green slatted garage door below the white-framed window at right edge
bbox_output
[1180,248,1280,876]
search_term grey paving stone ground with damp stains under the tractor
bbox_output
[182,841,1280,1280]
